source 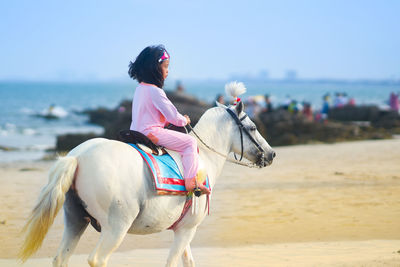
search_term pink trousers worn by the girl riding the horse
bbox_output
[144,128,199,179]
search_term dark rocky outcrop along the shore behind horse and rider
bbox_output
[56,92,400,151]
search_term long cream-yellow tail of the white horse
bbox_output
[19,156,78,262]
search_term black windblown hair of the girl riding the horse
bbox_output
[128,45,165,88]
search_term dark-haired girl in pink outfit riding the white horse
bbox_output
[128,45,210,194]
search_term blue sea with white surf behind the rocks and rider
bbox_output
[0,80,400,162]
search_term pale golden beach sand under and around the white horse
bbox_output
[0,139,400,266]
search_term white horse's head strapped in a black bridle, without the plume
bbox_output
[217,102,276,167]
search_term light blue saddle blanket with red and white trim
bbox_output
[129,144,210,195]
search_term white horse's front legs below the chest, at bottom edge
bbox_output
[166,226,197,267]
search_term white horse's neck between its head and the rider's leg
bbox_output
[191,110,231,186]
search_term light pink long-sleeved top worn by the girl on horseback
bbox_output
[130,83,187,134]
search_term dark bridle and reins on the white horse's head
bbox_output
[188,108,265,168]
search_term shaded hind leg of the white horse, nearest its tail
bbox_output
[53,190,89,267]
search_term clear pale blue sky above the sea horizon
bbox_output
[0,0,400,81]
